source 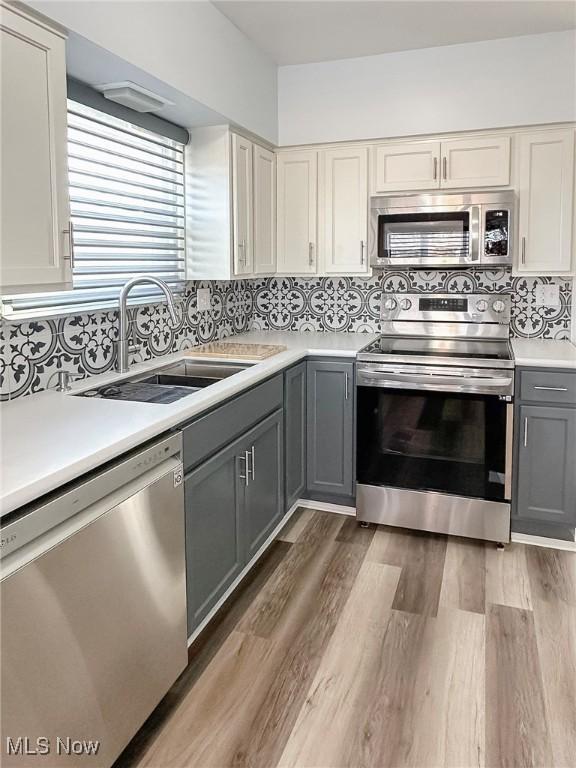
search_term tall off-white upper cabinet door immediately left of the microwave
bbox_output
[319,147,368,274]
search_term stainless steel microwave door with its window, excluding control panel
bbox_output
[370,205,480,267]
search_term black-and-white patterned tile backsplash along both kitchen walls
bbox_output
[0,270,572,400]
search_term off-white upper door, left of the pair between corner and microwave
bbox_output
[277,151,318,275]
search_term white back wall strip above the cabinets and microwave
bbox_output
[278,31,576,145]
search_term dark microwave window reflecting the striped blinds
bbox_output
[378,211,470,262]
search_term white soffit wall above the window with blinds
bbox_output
[28,0,278,142]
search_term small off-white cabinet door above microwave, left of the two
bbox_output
[370,141,440,195]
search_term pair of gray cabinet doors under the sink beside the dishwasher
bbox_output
[184,409,284,635]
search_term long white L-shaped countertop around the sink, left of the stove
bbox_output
[0,331,378,515]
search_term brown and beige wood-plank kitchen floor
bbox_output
[118,509,576,768]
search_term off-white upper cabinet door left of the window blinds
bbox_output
[0,6,72,294]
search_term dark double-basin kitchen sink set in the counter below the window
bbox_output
[77,360,253,404]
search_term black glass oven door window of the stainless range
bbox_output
[357,387,506,501]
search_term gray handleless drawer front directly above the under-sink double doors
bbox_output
[182,374,284,471]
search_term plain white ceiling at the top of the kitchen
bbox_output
[214,0,576,65]
